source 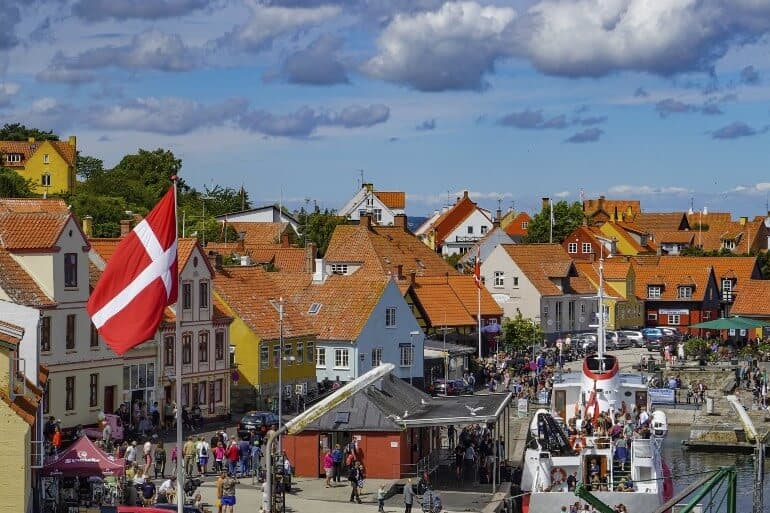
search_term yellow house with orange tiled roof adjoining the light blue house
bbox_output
[214,266,317,410]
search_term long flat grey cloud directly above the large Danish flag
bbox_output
[85,97,248,135]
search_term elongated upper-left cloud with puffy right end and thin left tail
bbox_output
[38,29,200,79]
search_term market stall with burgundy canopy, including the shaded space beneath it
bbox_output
[40,436,125,513]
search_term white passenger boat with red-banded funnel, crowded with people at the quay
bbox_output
[521,352,673,513]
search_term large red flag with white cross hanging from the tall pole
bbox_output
[86,187,178,355]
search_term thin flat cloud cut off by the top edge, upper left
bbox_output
[72,0,214,21]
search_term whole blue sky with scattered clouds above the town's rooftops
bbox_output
[0,0,770,215]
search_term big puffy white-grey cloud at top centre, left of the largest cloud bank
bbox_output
[362,2,516,91]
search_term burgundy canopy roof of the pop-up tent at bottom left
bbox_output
[41,436,125,477]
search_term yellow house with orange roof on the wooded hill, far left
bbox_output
[0,136,77,195]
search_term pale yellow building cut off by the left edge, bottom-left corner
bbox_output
[0,321,45,512]
